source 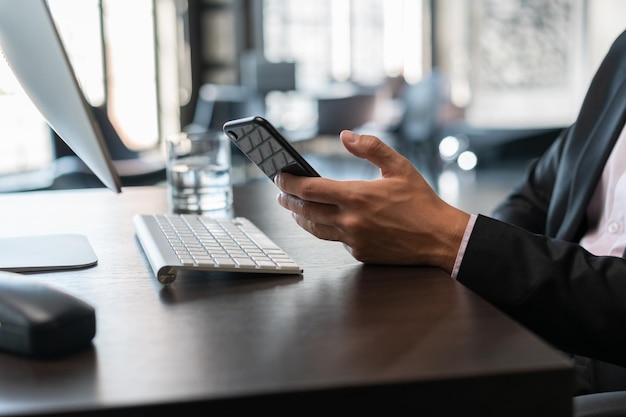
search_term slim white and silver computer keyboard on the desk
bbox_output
[133,214,302,284]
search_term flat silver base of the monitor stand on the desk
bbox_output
[0,234,98,272]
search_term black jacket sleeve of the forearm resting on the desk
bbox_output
[457,216,626,365]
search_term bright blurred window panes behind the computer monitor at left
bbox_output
[0,0,180,181]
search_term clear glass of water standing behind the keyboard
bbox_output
[166,131,233,213]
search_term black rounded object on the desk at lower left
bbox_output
[0,271,96,358]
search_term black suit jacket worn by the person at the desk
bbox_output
[458,32,626,372]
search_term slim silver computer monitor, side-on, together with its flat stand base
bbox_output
[0,0,121,272]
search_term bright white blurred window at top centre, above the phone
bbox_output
[263,0,425,89]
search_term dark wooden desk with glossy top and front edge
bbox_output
[0,183,572,417]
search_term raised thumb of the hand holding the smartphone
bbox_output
[339,130,411,177]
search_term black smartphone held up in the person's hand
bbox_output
[224,116,320,181]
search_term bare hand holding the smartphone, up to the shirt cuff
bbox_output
[274,131,469,273]
